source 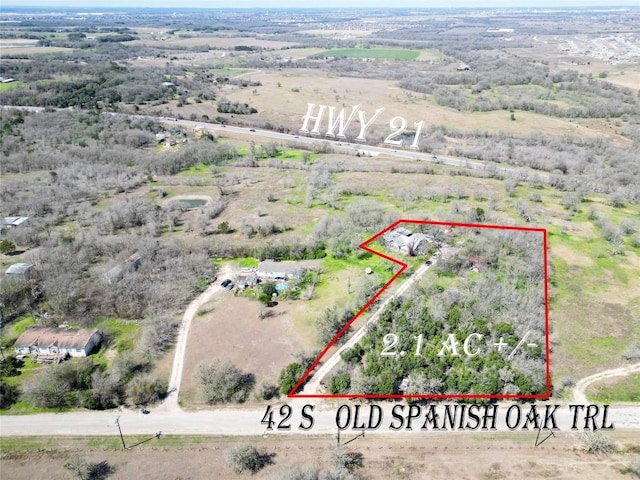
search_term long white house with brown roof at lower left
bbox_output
[13,327,102,357]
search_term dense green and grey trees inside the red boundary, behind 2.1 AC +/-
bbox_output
[330,232,545,394]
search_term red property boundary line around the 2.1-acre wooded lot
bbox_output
[287,219,551,400]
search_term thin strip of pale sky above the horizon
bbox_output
[7,0,640,11]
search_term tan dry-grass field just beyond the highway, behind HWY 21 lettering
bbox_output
[222,69,629,145]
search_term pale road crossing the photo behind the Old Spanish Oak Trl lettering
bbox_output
[0,399,640,438]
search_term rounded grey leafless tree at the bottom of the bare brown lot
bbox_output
[197,362,255,405]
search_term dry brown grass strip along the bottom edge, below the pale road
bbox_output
[2,434,637,480]
